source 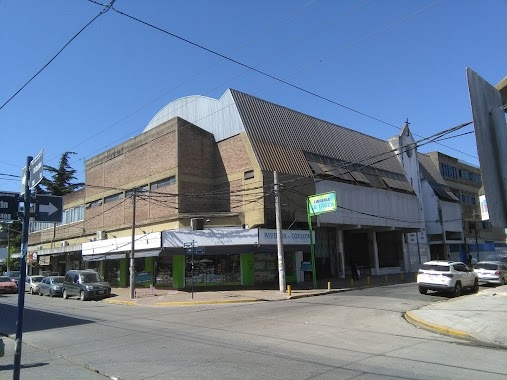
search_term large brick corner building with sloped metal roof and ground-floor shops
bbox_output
[29,90,444,288]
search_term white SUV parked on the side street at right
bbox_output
[417,261,479,297]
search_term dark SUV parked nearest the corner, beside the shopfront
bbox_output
[62,269,111,301]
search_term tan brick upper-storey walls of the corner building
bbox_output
[33,118,262,246]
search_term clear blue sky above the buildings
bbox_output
[0,0,507,191]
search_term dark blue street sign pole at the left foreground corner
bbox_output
[12,156,32,380]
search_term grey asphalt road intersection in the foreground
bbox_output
[0,284,507,380]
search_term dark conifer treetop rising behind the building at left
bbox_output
[39,152,84,196]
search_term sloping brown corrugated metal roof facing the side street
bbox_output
[231,90,405,175]
